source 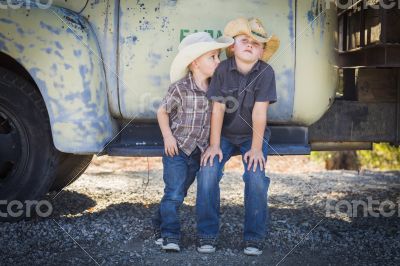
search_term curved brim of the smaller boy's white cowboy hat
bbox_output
[170,36,234,83]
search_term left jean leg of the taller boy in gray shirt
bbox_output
[196,139,235,238]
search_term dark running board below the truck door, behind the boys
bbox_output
[103,124,311,157]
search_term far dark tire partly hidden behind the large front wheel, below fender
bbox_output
[50,153,93,192]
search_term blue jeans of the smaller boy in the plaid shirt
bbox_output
[152,148,201,239]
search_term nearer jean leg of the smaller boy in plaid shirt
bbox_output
[160,151,188,239]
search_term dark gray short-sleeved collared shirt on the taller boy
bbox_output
[207,57,277,144]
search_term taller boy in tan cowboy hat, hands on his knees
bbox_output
[196,18,279,255]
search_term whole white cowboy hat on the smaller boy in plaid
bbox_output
[170,32,234,83]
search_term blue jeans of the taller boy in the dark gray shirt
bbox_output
[196,137,270,241]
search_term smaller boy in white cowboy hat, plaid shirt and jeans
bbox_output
[153,32,233,251]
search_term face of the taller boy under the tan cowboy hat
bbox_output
[231,35,264,63]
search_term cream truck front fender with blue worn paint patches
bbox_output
[0,7,116,153]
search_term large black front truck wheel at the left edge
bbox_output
[0,68,61,221]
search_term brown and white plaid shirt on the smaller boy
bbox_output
[161,72,211,155]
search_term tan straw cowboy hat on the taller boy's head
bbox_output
[224,18,280,62]
